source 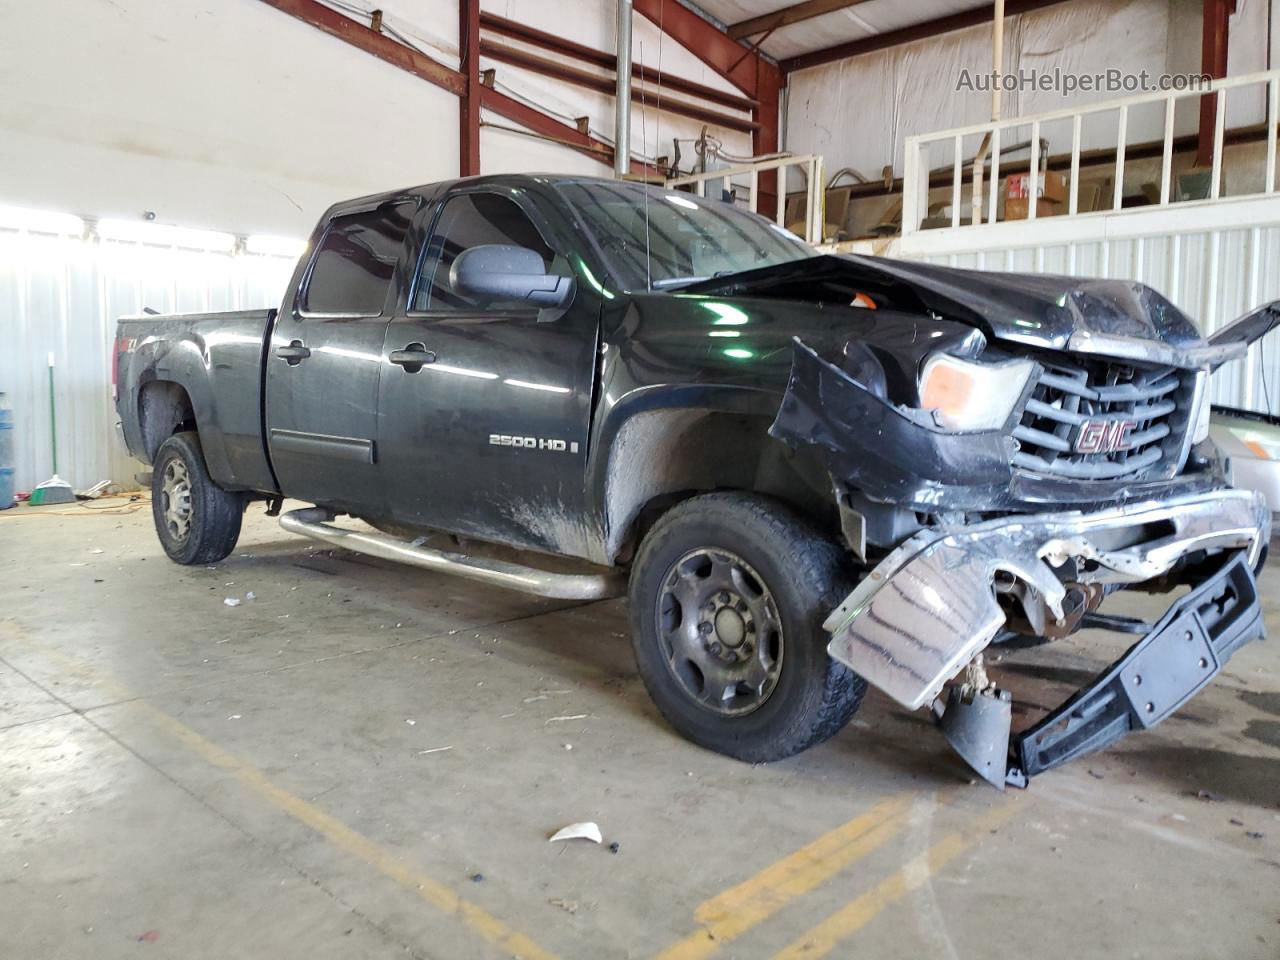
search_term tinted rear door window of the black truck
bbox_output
[302,201,417,316]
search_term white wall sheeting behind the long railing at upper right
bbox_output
[787,0,1280,179]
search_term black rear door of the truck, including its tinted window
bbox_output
[266,198,417,513]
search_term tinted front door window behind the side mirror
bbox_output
[413,193,556,310]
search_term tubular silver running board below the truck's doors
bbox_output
[280,507,626,600]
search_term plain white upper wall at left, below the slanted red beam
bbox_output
[0,0,458,237]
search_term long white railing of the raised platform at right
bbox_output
[902,69,1280,238]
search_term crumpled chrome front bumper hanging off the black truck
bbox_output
[824,489,1271,709]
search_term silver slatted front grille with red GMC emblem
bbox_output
[1012,358,1194,480]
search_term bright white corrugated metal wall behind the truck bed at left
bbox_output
[0,229,293,490]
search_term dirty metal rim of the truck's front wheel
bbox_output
[654,547,782,717]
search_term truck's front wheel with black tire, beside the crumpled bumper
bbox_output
[630,493,867,763]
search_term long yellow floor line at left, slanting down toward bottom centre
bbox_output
[3,628,558,960]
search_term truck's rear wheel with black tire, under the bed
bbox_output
[151,433,244,564]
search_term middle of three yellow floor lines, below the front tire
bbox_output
[654,794,931,960]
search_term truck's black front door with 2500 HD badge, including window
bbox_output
[378,187,599,556]
